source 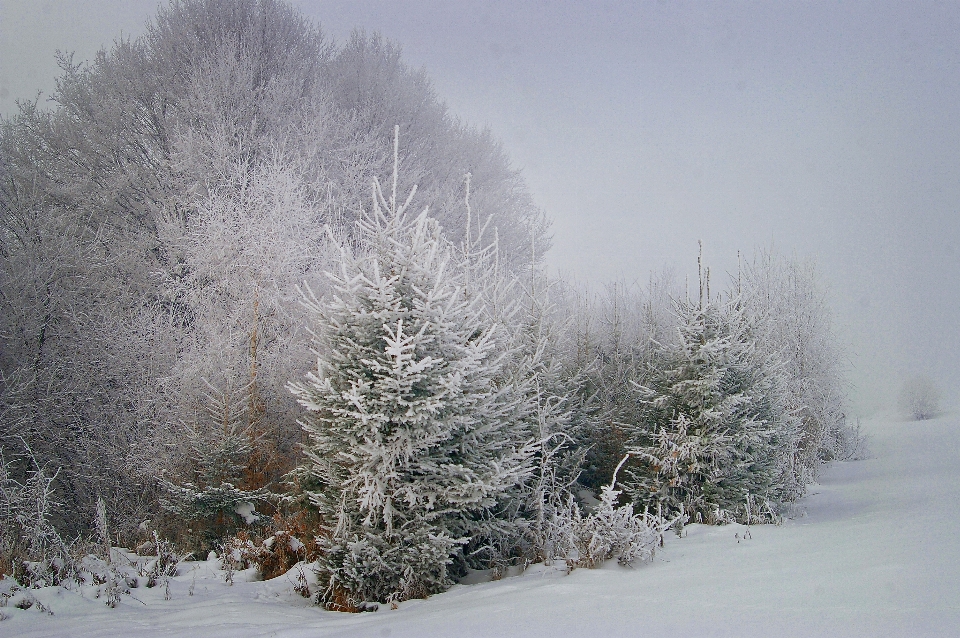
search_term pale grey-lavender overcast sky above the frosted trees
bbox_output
[0,0,960,412]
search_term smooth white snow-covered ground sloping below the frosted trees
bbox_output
[7,416,960,638]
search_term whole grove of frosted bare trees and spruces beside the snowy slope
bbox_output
[0,0,856,610]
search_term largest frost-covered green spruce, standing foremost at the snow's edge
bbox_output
[291,139,531,610]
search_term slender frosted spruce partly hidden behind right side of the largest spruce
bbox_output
[459,173,589,569]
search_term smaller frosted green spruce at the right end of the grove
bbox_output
[627,278,798,523]
